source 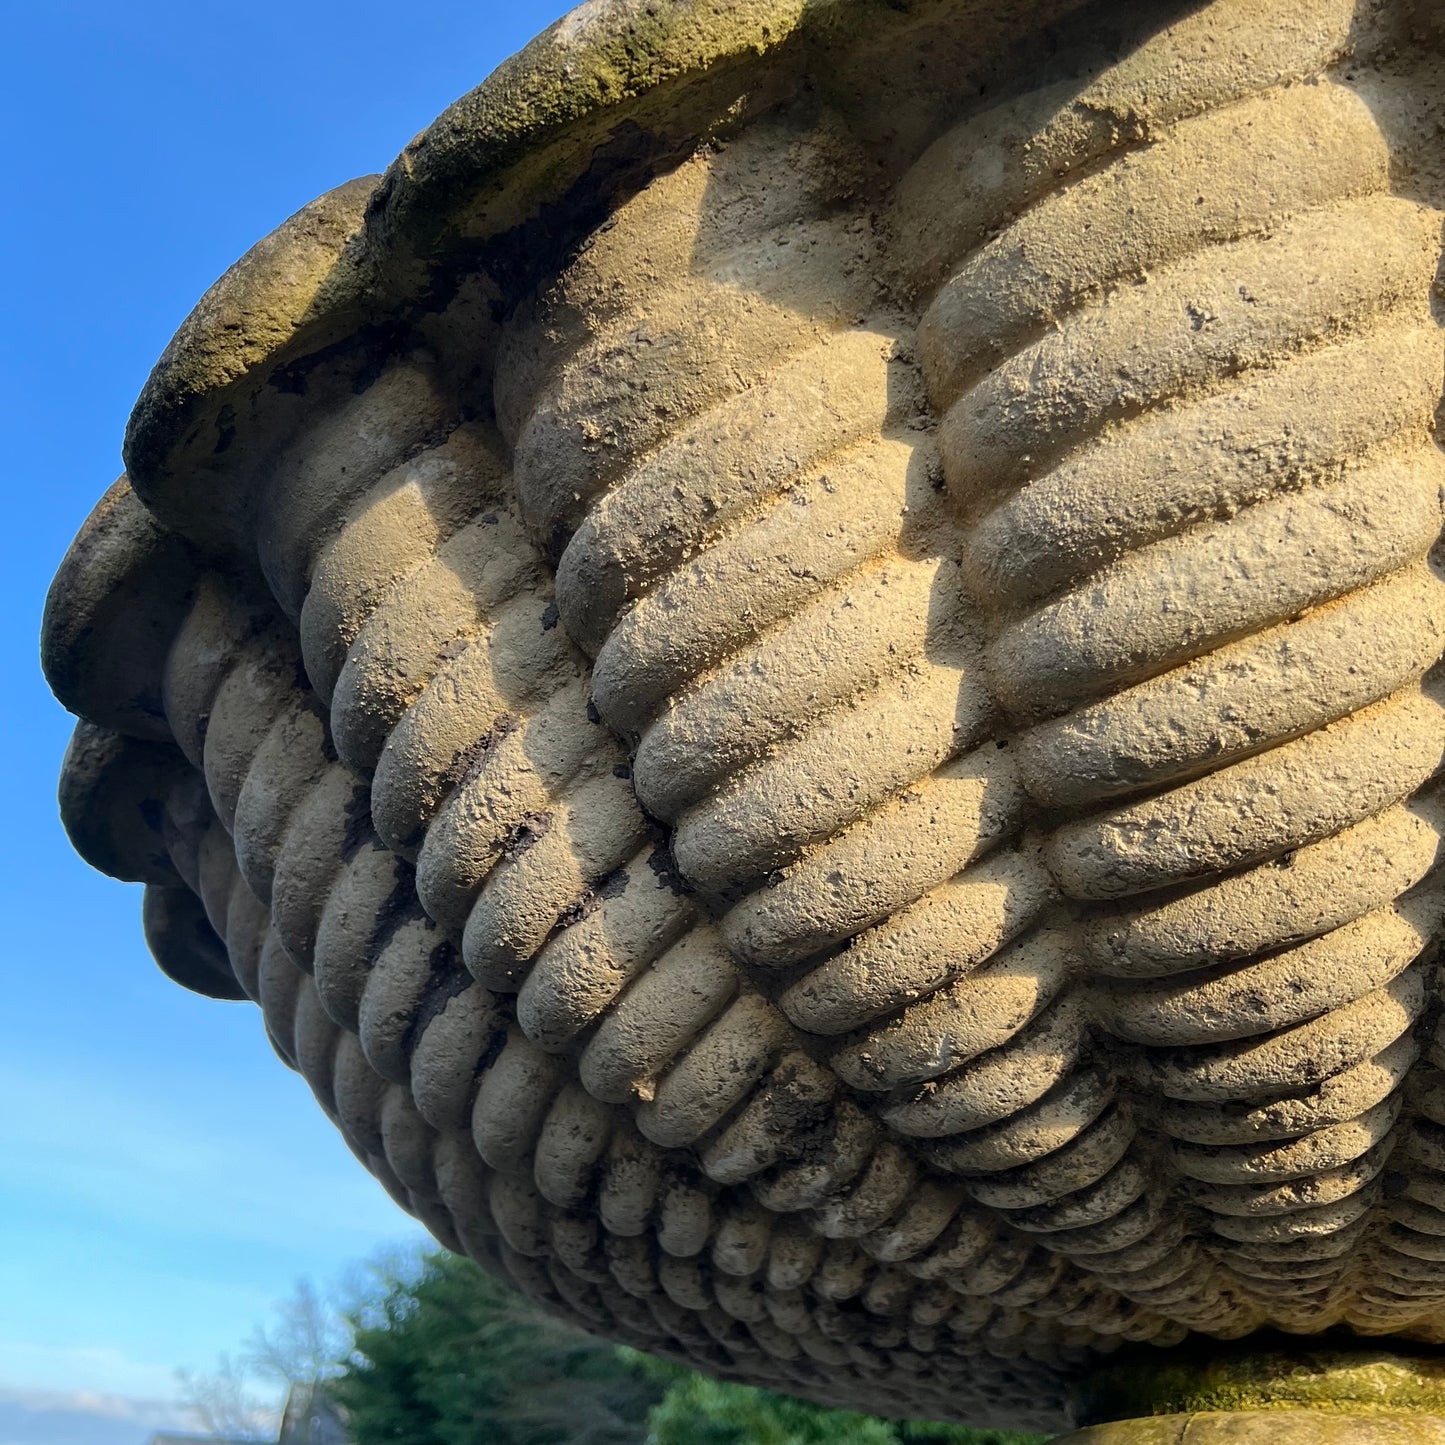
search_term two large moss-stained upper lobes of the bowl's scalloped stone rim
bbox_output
[124,0,884,525]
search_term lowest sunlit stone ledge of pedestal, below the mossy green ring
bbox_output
[1053,1410,1445,1445]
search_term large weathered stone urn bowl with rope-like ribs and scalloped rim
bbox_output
[45,0,1445,1428]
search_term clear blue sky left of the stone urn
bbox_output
[0,0,565,1445]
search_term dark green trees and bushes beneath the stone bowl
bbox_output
[329,1253,1040,1445]
